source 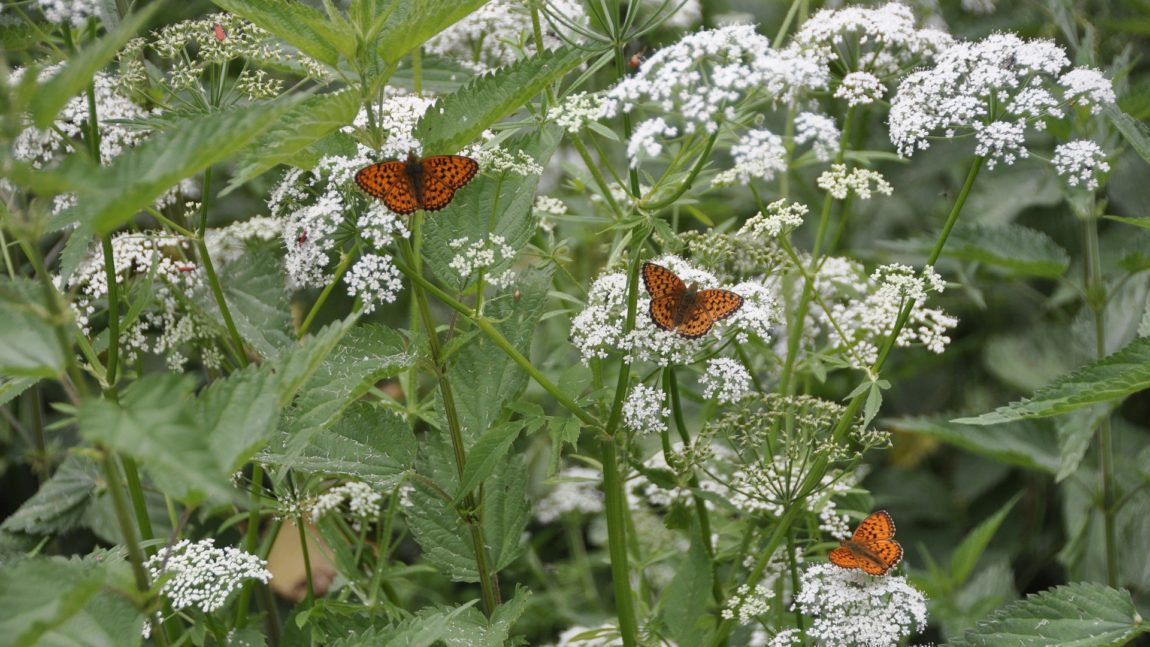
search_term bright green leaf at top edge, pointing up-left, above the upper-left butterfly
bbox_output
[212,0,347,68]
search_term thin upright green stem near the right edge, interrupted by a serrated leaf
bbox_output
[1082,200,1118,587]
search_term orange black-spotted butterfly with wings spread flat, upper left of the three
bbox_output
[355,153,480,216]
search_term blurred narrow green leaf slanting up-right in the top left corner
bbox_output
[30,5,160,130]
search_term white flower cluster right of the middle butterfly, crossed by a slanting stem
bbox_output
[811,257,958,369]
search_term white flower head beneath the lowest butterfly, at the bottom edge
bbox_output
[795,563,927,647]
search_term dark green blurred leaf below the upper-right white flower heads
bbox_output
[894,224,1071,278]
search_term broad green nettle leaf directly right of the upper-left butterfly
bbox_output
[423,128,562,290]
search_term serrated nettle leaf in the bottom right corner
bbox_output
[952,581,1150,647]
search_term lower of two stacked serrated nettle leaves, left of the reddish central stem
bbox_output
[260,402,419,490]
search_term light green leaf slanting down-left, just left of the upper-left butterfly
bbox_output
[221,90,360,195]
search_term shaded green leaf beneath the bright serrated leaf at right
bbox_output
[883,417,1060,475]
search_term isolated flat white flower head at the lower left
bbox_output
[145,539,271,614]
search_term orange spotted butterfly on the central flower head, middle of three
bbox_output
[643,261,743,339]
